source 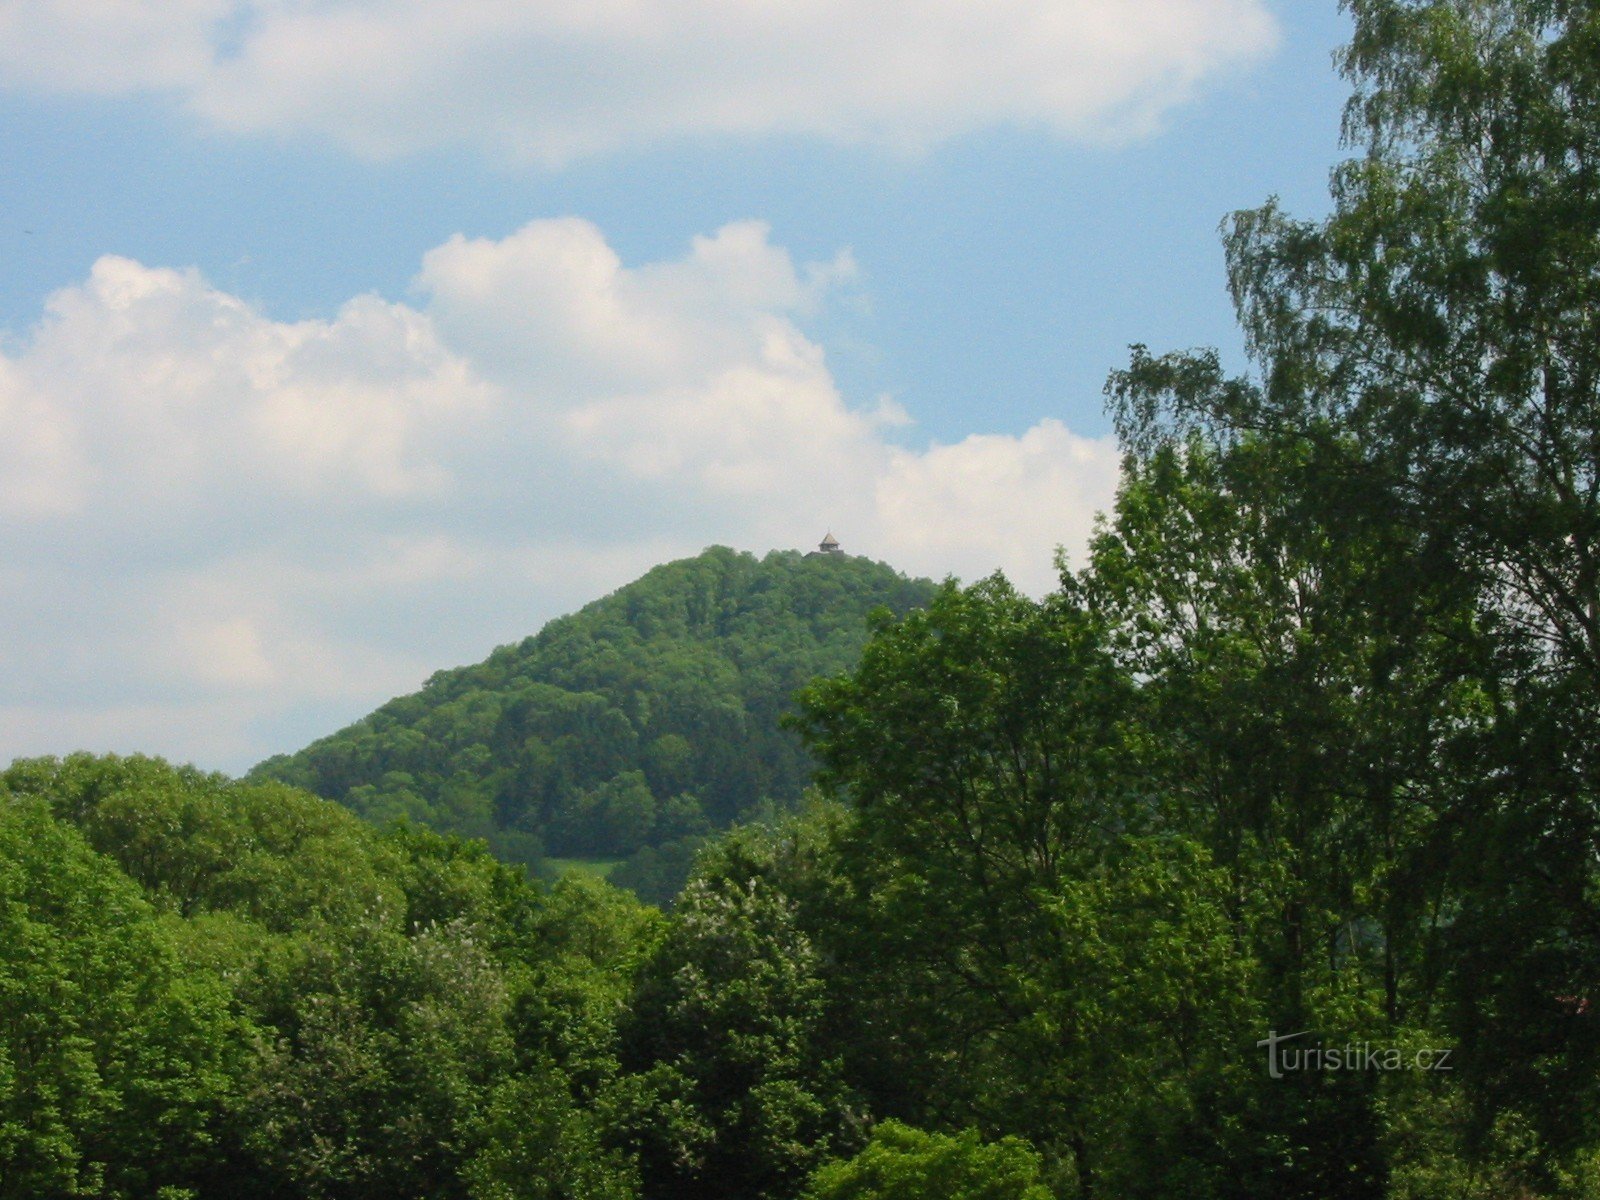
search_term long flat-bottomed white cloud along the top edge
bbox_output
[0,0,1275,163]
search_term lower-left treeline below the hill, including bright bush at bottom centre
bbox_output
[0,755,1048,1200]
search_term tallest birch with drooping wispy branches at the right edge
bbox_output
[1112,0,1600,1189]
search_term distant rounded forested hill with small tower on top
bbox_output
[243,547,933,889]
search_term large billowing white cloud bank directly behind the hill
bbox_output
[0,219,1117,768]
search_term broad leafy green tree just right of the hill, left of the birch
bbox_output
[802,579,1259,1195]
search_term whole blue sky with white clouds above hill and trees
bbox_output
[0,0,1347,773]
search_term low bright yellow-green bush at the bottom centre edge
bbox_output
[805,1122,1051,1200]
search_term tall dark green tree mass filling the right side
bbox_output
[761,0,1600,1200]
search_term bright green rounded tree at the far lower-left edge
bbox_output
[0,789,242,1197]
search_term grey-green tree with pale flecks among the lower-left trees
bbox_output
[246,923,514,1197]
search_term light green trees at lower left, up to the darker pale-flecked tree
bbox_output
[0,755,659,1200]
